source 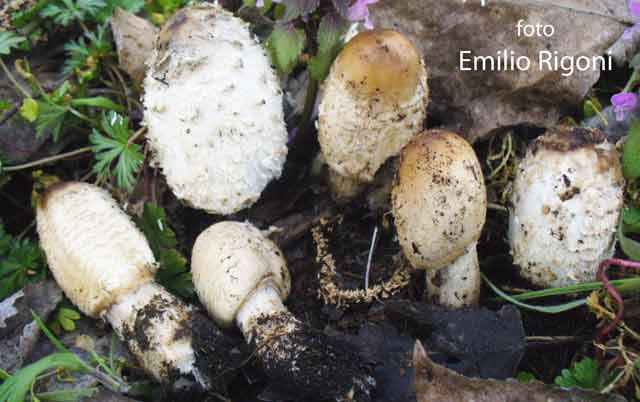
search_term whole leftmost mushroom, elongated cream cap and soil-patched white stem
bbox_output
[37,182,213,388]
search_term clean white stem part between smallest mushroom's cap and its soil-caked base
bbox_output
[236,285,287,341]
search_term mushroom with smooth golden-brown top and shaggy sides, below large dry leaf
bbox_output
[318,30,429,199]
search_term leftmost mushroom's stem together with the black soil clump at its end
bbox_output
[105,283,237,389]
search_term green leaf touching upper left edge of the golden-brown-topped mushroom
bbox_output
[309,13,348,81]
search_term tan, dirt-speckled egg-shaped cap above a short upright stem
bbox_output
[392,130,487,269]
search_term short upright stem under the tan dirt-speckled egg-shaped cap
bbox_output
[426,243,481,308]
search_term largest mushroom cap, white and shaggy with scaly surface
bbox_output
[144,4,288,214]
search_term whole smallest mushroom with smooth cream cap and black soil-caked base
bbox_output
[192,222,373,401]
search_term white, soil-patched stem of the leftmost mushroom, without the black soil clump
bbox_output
[104,282,201,388]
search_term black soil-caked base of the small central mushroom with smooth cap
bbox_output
[251,312,375,402]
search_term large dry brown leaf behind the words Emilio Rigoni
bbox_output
[371,0,632,141]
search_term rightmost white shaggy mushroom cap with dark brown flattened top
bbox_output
[509,127,624,287]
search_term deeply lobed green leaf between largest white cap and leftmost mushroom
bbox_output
[89,112,144,191]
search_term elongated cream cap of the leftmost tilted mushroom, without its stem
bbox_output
[37,182,157,318]
